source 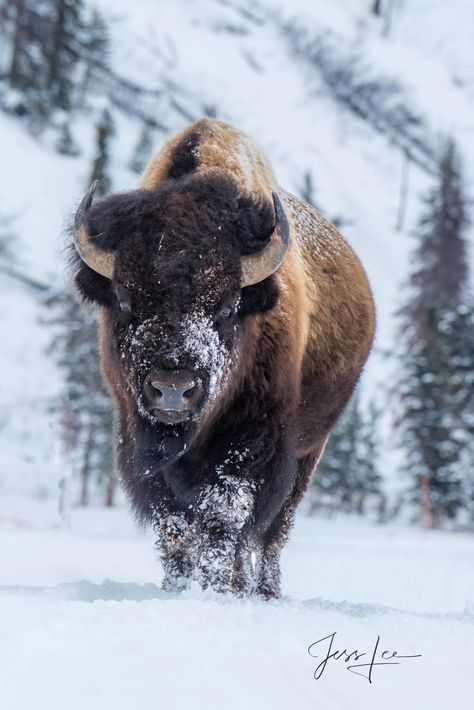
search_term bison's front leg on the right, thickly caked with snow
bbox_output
[196,475,255,592]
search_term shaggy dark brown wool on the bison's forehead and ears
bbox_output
[73,175,278,322]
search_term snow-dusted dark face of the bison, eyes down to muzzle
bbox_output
[110,260,241,432]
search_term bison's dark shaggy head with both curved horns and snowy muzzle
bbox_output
[74,175,289,462]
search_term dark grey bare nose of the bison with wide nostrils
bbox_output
[143,370,202,419]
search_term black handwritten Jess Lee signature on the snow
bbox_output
[308,631,422,683]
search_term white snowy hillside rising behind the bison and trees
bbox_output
[0,0,474,494]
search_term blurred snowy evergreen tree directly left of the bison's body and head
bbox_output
[47,290,116,505]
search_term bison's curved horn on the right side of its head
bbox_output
[240,192,290,288]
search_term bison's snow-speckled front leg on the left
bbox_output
[155,514,197,592]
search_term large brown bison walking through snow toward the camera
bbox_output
[73,119,374,598]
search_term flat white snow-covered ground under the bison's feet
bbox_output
[0,501,474,710]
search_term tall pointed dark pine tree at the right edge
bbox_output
[400,141,474,526]
